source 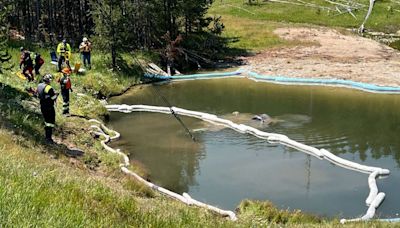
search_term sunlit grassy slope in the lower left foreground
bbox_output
[0,130,231,227]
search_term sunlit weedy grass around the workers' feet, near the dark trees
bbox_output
[0,43,148,120]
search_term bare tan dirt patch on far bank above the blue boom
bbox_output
[244,28,400,86]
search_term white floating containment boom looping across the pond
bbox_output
[100,104,390,223]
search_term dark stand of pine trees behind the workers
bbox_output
[0,0,225,69]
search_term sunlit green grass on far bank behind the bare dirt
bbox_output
[208,0,400,52]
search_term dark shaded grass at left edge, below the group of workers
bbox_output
[0,83,84,157]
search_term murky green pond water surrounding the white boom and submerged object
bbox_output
[109,79,400,217]
